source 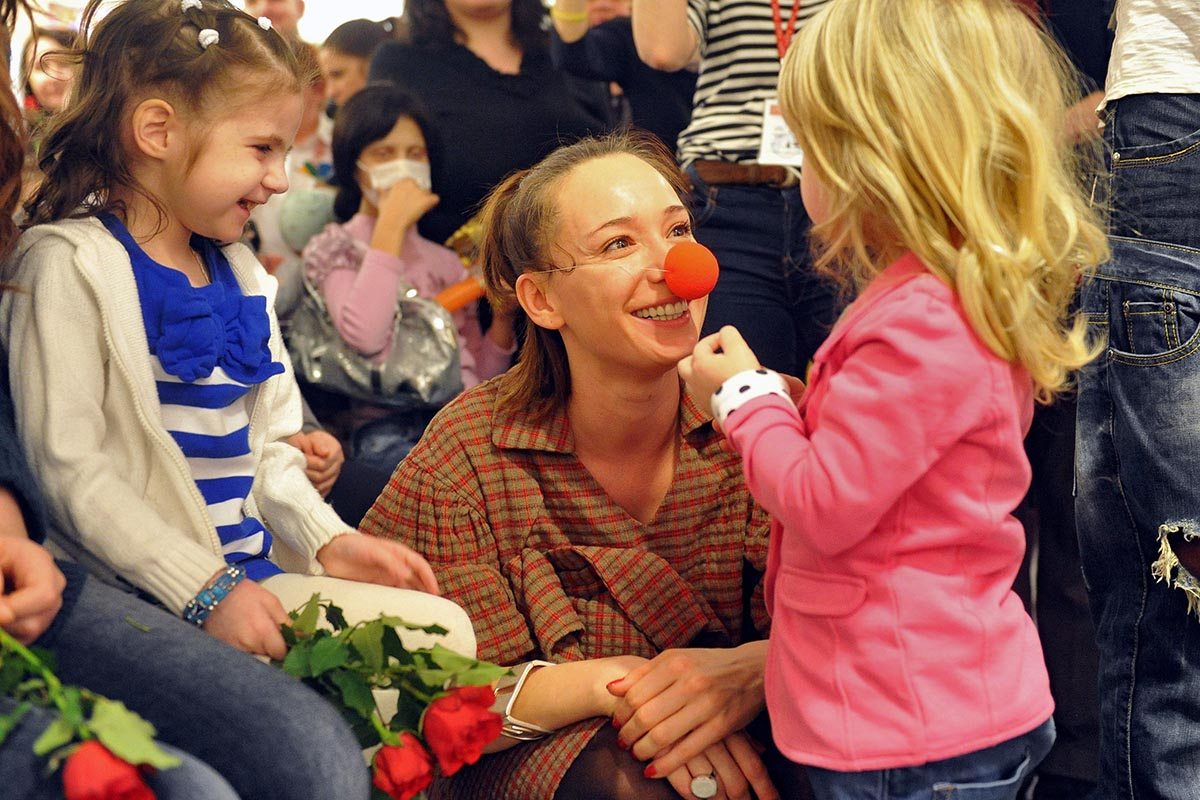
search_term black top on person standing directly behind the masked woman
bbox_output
[371,42,608,242]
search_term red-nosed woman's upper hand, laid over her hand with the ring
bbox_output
[608,642,767,776]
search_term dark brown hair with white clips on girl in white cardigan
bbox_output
[25,0,308,224]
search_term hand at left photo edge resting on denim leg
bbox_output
[0,532,67,644]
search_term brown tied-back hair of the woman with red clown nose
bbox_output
[479,131,689,413]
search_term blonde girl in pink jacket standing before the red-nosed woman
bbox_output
[680,0,1106,800]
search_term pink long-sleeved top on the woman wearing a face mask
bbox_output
[304,213,512,389]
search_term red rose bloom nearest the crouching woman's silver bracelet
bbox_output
[422,686,504,775]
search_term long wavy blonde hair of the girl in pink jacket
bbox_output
[779,0,1108,402]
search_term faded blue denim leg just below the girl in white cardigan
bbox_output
[31,578,371,800]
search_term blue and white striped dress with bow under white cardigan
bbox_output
[101,215,283,581]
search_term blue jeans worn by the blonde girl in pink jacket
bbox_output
[809,720,1054,800]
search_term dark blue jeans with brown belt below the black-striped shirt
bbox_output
[688,167,840,378]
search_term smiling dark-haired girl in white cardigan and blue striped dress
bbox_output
[0,0,474,657]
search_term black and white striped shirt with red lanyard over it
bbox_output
[679,0,829,164]
